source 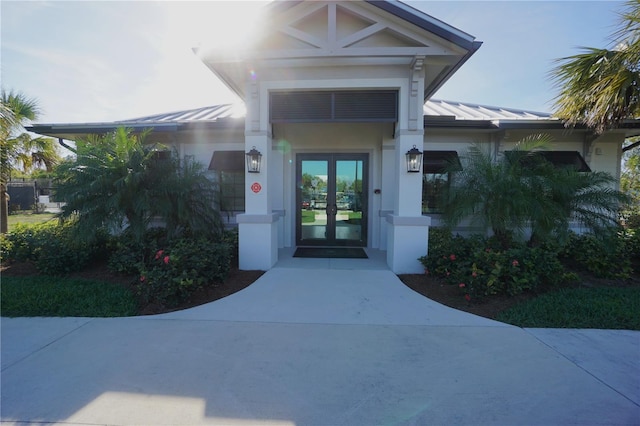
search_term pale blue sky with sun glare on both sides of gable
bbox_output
[0,0,623,123]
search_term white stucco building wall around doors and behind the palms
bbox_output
[168,123,623,250]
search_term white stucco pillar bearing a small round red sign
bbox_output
[236,77,279,271]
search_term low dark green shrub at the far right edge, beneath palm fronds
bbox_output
[561,233,632,279]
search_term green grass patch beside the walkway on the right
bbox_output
[496,287,640,330]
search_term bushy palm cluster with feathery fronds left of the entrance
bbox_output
[56,128,222,241]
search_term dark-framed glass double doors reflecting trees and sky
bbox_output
[296,154,368,247]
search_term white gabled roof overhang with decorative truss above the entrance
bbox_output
[194,1,482,100]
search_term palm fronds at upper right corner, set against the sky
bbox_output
[550,0,640,135]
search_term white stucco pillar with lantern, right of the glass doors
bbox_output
[387,58,431,274]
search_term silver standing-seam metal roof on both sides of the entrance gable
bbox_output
[114,100,552,125]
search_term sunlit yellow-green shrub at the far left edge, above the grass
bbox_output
[3,221,106,275]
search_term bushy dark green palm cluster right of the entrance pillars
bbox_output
[443,135,628,248]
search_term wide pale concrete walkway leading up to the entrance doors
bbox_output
[1,261,640,425]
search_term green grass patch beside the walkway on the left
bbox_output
[0,276,137,317]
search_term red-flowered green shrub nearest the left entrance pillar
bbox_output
[137,239,232,306]
